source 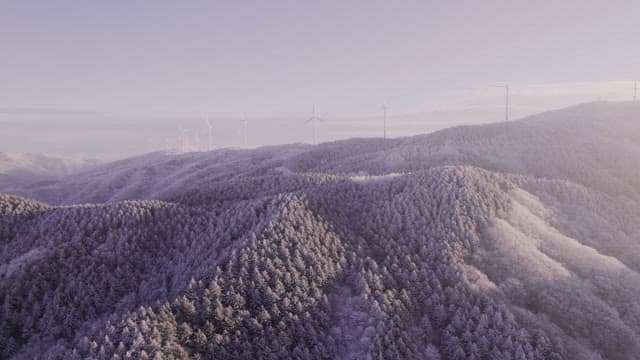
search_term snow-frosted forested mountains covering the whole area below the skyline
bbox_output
[0,103,640,360]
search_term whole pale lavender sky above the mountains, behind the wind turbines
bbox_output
[0,0,640,158]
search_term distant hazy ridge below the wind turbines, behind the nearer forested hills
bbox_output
[5,103,640,204]
